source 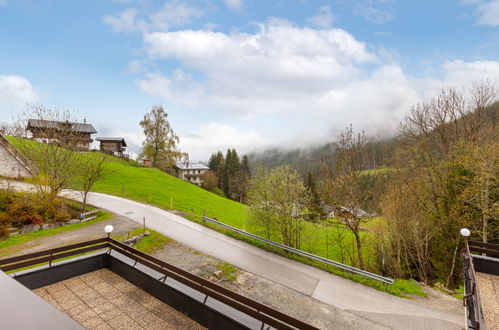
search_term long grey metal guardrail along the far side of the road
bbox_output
[203,216,394,285]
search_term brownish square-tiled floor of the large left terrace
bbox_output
[33,269,204,330]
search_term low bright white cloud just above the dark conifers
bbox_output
[180,122,265,161]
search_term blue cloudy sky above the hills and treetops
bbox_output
[0,0,499,161]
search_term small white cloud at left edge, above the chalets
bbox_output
[0,75,40,107]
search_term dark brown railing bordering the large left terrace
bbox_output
[0,237,317,330]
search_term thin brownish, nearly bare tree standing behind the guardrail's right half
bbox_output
[322,125,372,269]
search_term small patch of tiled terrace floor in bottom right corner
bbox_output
[475,272,499,330]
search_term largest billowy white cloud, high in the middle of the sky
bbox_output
[137,21,378,115]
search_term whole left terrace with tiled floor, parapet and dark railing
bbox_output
[0,227,315,329]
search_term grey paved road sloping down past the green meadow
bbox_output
[2,183,464,329]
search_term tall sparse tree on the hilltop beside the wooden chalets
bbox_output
[139,105,188,173]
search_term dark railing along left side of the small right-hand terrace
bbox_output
[462,241,486,330]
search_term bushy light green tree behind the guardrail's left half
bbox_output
[248,165,307,248]
